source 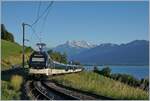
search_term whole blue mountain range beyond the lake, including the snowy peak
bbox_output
[54,40,149,65]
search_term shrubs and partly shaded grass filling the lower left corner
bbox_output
[1,68,27,100]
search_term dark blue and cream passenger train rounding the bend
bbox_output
[28,43,83,76]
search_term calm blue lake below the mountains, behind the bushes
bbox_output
[84,66,149,79]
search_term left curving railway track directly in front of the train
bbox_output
[25,81,76,100]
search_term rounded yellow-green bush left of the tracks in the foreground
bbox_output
[10,75,23,91]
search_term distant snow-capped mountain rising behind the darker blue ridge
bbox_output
[53,40,97,58]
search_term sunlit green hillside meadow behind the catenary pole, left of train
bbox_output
[1,40,30,70]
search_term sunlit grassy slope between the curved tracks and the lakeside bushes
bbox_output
[52,72,149,100]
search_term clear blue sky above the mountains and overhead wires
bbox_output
[1,1,149,48]
